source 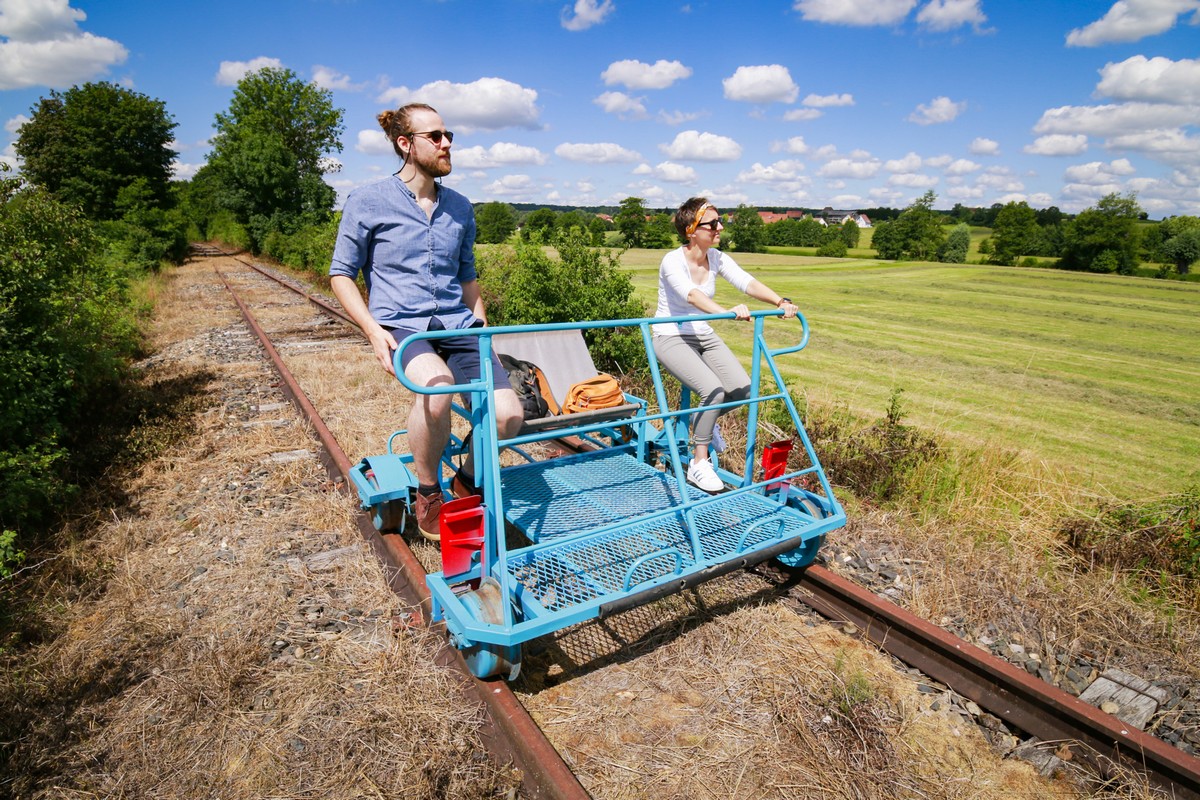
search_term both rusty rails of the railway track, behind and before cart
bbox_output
[196,247,1200,798]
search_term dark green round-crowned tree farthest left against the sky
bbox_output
[16,83,178,219]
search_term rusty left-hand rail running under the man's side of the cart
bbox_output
[214,270,590,800]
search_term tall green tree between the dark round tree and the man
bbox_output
[209,67,344,249]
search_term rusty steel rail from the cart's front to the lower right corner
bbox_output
[791,565,1200,800]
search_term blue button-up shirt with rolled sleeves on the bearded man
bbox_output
[329,175,476,330]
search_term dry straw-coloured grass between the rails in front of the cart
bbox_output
[526,603,1076,800]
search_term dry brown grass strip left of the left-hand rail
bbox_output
[0,261,516,798]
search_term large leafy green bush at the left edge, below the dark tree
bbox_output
[0,171,138,542]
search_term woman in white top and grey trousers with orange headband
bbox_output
[653,197,797,492]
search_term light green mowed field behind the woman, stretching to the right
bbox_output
[622,251,1200,499]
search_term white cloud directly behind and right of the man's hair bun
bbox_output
[379,78,541,132]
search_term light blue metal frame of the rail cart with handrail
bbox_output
[352,311,846,678]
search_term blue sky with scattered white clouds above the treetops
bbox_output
[0,0,1200,219]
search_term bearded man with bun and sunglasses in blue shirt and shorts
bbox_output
[329,103,523,541]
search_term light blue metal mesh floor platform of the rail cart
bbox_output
[502,449,816,612]
